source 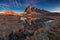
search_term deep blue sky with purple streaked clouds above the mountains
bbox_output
[0,0,60,13]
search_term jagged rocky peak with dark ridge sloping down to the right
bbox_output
[25,6,49,14]
